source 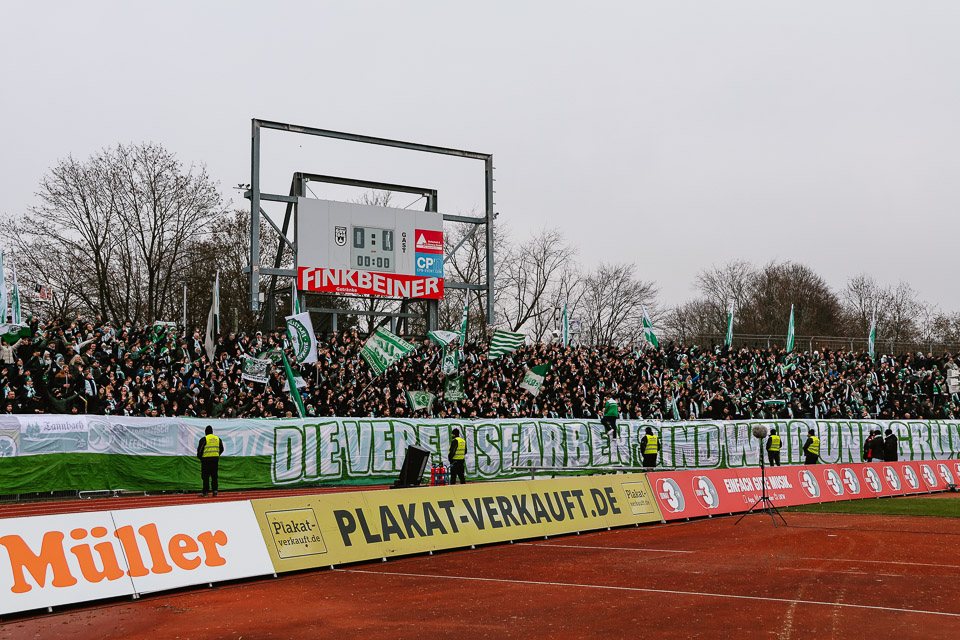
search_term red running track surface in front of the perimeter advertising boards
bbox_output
[0,513,960,640]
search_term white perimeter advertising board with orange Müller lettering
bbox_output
[0,501,273,614]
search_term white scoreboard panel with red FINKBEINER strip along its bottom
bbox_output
[295,198,443,299]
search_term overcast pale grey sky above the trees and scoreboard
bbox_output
[0,0,960,310]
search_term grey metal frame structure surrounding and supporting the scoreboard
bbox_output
[244,118,496,330]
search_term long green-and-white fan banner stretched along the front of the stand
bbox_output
[0,415,960,495]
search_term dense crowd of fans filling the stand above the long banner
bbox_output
[0,318,960,420]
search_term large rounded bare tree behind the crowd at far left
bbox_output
[3,143,222,322]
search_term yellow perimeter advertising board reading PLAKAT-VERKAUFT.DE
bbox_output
[251,474,660,572]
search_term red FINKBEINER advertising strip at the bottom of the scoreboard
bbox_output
[297,267,443,300]
